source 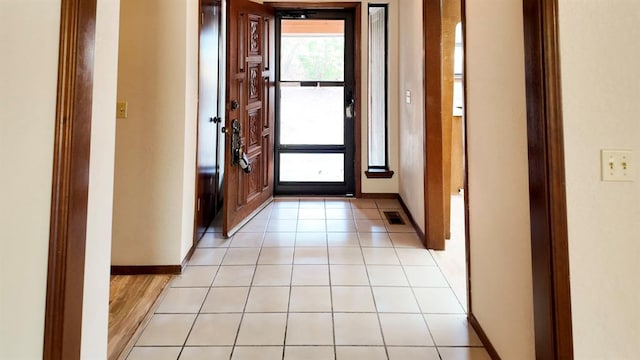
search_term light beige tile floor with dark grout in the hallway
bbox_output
[128,198,489,360]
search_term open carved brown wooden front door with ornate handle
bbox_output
[223,0,275,236]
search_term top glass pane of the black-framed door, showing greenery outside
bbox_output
[280,20,345,81]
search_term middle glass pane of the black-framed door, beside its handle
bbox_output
[280,83,344,145]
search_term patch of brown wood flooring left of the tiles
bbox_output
[108,275,171,360]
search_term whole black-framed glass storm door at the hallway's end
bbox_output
[275,10,355,195]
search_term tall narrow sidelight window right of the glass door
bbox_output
[369,6,387,167]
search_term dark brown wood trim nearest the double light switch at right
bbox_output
[523,0,573,359]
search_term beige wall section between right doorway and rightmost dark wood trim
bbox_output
[465,0,534,360]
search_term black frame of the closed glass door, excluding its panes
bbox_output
[274,8,358,195]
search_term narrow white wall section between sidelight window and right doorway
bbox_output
[391,0,425,232]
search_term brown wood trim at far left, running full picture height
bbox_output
[43,0,96,360]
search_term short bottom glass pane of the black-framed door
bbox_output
[280,153,344,182]
